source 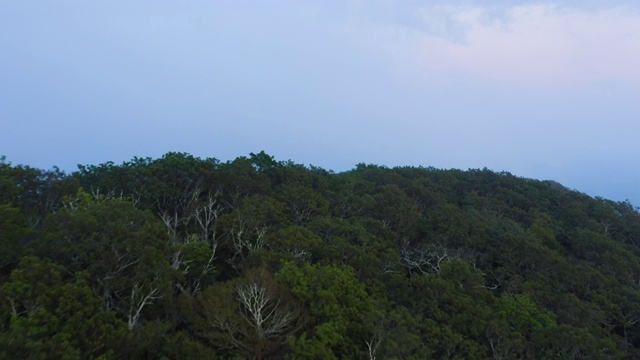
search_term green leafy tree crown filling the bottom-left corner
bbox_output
[0,257,126,359]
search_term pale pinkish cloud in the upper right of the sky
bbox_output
[373,4,640,86]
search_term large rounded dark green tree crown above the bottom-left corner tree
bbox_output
[34,192,176,328]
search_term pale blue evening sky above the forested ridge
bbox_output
[0,0,640,206]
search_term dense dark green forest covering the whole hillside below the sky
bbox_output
[0,152,640,359]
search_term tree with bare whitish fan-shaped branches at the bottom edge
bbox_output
[182,268,299,359]
